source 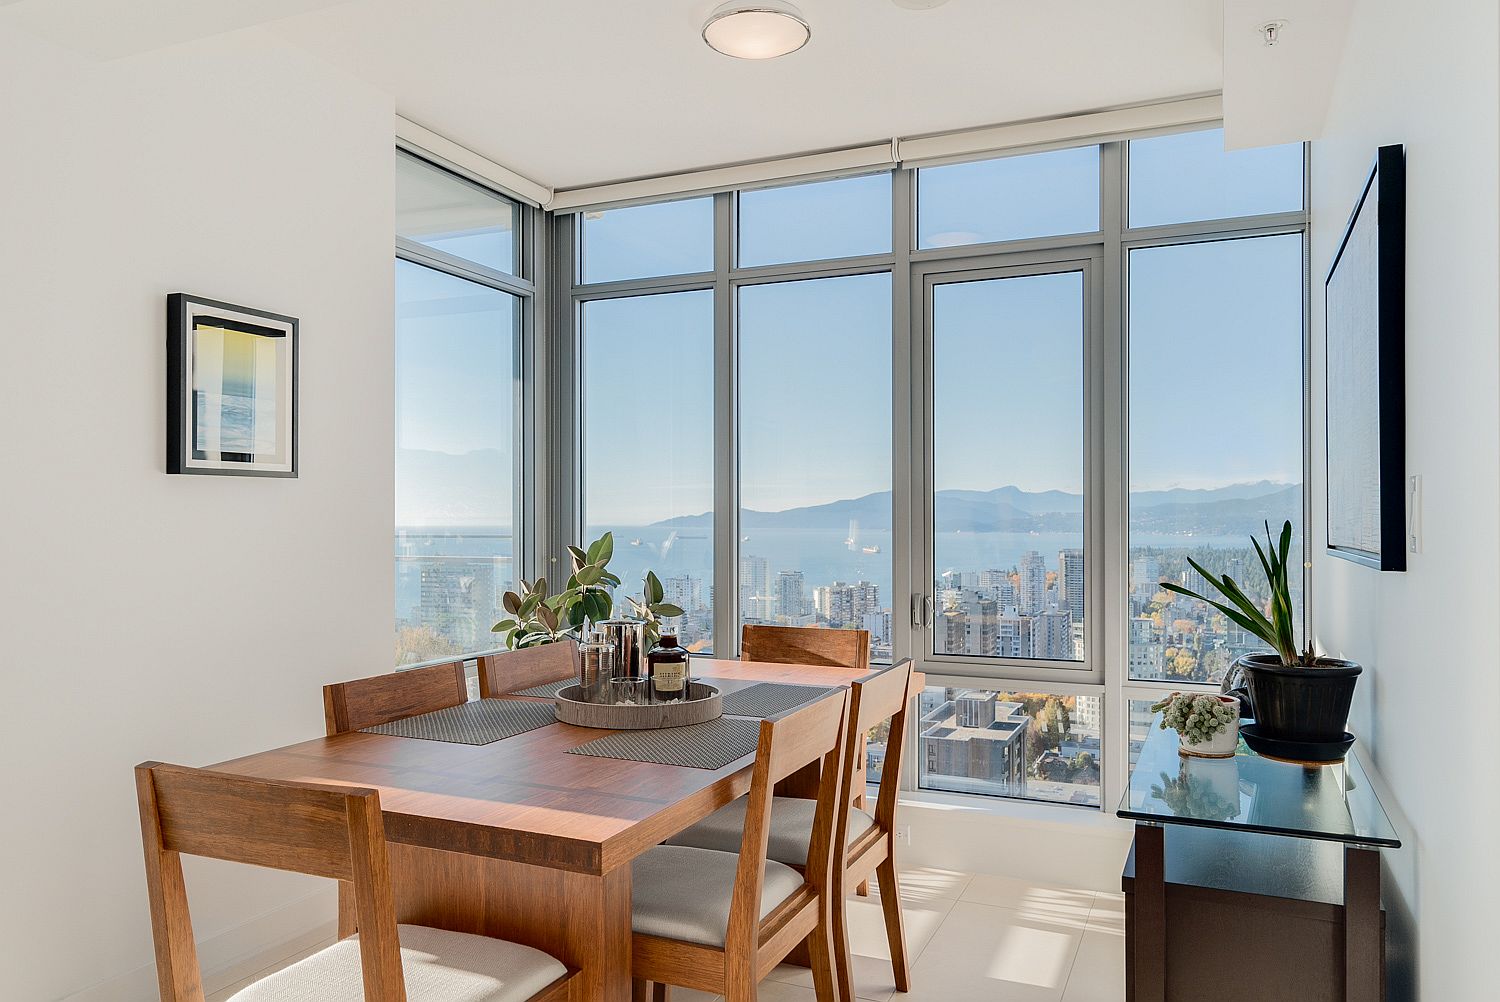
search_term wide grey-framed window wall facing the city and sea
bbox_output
[557,129,1307,806]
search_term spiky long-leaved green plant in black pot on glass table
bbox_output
[1161,522,1362,747]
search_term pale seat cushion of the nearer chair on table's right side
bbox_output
[630,846,803,947]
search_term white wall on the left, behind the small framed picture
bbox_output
[0,27,395,1002]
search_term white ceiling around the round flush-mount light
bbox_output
[269,0,1223,188]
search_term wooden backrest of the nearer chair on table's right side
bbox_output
[725,689,849,954]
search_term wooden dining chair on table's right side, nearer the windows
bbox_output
[669,659,917,999]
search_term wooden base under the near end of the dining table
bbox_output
[390,843,632,1002]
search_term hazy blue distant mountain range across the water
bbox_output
[657,480,1302,536]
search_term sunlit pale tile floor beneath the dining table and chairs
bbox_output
[209,867,1125,1002]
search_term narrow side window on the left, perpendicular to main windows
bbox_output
[395,152,533,665]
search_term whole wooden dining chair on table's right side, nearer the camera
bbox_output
[630,689,849,1002]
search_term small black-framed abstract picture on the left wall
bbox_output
[167,293,300,477]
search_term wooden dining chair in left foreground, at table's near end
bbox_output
[135,762,578,1002]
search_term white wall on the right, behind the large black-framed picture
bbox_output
[1313,0,1500,1001]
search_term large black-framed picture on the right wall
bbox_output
[1323,146,1407,572]
